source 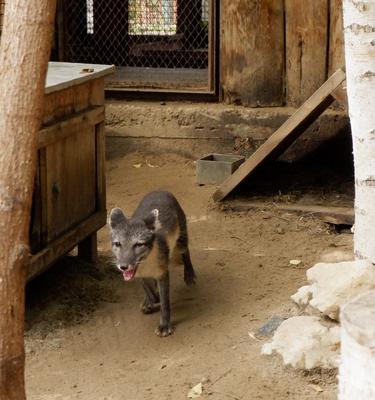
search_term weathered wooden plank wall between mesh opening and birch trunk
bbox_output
[220,0,344,107]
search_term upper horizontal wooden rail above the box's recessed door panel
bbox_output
[38,106,104,149]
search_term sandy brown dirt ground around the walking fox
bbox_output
[26,148,352,400]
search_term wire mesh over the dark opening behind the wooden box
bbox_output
[63,0,211,69]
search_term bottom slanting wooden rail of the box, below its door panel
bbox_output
[28,212,107,281]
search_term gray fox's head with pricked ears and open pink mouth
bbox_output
[109,208,159,281]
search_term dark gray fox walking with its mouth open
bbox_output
[109,192,196,336]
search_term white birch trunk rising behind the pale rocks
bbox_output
[343,0,375,263]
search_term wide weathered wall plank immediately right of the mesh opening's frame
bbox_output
[220,0,284,107]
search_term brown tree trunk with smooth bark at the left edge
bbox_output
[0,0,55,400]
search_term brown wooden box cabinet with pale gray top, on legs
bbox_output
[29,63,113,279]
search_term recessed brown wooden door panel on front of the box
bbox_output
[46,125,96,242]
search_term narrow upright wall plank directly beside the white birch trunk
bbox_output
[328,0,345,75]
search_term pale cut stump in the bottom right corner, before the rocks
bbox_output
[339,290,375,400]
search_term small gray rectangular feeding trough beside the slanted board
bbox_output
[196,153,245,185]
